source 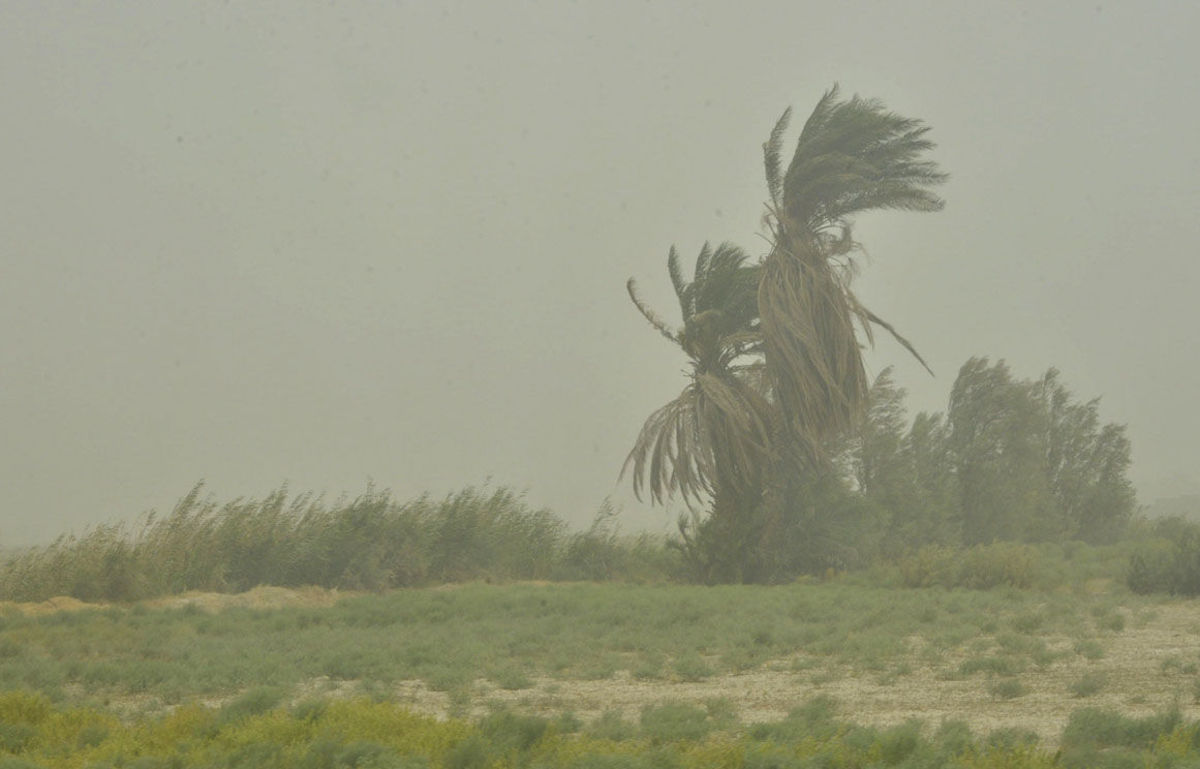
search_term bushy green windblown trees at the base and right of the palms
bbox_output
[680,358,1135,582]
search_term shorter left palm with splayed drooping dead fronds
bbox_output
[622,244,774,537]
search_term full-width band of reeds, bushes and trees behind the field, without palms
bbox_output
[7,358,1200,601]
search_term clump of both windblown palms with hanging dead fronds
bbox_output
[625,86,946,579]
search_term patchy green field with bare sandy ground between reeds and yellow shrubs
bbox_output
[0,578,1200,765]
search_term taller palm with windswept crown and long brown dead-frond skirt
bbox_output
[758,85,947,465]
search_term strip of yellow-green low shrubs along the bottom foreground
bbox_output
[16,693,1200,769]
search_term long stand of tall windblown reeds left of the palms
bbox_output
[0,483,670,601]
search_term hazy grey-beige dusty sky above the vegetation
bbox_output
[0,0,1200,545]
